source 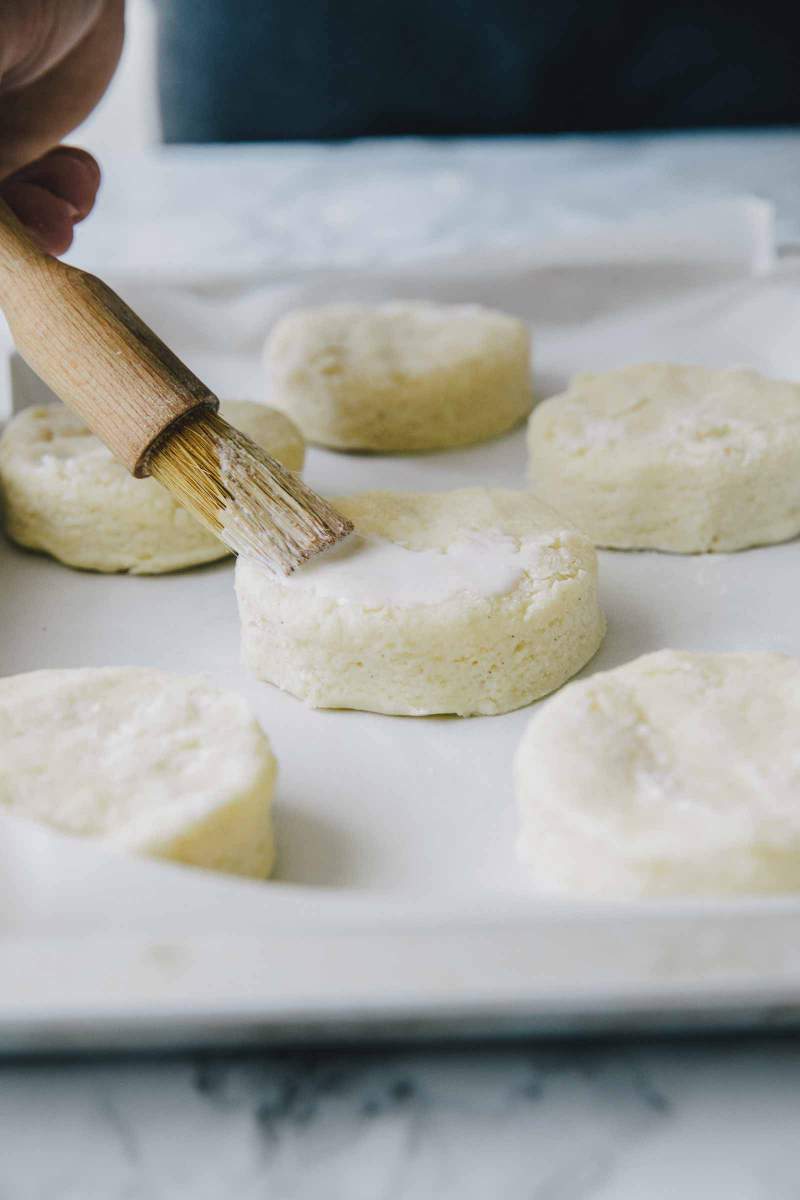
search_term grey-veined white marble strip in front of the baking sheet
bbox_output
[0,1039,800,1200]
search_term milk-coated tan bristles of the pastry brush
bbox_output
[148,409,353,575]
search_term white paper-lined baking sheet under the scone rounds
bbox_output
[0,202,800,1049]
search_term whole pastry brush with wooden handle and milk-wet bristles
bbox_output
[0,200,353,575]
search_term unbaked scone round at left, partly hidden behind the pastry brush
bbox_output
[0,401,305,575]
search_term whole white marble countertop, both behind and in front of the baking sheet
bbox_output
[0,131,800,1200]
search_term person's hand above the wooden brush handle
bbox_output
[0,0,124,254]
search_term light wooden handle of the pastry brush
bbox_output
[0,200,217,475]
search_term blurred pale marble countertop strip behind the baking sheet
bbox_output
[71,131,800,278]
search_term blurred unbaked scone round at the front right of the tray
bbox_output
[515,650,800,899]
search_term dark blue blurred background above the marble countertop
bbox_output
[158,0,800,142]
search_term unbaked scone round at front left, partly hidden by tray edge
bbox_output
[0,667,276,877]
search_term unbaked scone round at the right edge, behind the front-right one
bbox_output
[528,364,800,553]
